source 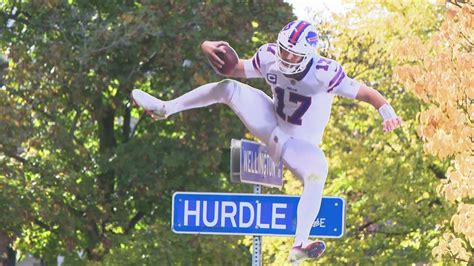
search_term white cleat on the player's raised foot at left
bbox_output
[130,89,168,120]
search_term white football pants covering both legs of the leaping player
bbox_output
[165,79,328,246]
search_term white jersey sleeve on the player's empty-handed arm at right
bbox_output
[327,61,362,99]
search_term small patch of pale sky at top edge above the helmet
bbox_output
[285,0,350,20]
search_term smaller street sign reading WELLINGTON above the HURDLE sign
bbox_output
[231,139,283,188]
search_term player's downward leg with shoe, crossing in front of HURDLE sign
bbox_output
[281,139,328,261]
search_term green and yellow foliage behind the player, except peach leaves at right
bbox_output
[0,0,474,265]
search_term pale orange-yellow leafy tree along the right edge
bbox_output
[396,2,474,264]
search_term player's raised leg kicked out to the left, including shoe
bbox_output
[132,79,277,143]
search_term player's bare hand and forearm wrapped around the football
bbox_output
[201,41,246,78]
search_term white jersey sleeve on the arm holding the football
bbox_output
[244,43,276,78]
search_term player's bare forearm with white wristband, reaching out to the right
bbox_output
[356,85,402,132]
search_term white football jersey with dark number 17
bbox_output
[244,43,361,145]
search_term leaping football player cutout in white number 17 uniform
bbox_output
[132,20,402,263]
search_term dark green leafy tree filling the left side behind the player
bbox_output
[0,0,291,264]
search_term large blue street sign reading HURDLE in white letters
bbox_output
[171,192,345,238]
